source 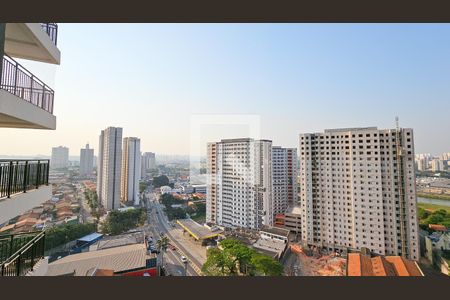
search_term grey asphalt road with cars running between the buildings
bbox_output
[146,194,201,276]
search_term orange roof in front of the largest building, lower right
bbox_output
[347,253,423,276]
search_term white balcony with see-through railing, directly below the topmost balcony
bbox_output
[0,55,56,130]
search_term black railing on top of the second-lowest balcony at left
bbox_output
[0,159,50,200]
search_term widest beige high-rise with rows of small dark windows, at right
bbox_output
[299,127,419,260]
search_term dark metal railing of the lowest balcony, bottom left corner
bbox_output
[0,231,45,276]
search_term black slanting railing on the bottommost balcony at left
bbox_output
[0,231,45,276]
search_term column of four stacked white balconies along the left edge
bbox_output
[0,23,61,276]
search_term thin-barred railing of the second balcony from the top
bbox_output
[0,54,55,114]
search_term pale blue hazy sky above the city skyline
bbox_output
[0,24,450,155]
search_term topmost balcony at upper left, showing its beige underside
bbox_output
[5,23,61,65]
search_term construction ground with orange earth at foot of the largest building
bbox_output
[282,244,346,276]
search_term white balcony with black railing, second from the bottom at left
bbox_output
[0,159,52,224]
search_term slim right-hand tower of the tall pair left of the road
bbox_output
[120,137,141,205]
